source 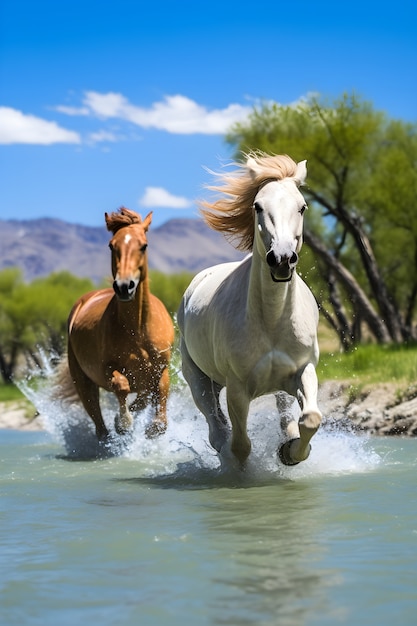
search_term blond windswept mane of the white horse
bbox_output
[199,150,297,250]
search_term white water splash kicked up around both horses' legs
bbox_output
[18,353,381,484]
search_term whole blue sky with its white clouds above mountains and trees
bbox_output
[0,0,417,226]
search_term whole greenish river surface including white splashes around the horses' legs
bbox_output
[0,368,417,626]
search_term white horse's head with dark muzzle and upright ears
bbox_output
[246,157,307,282]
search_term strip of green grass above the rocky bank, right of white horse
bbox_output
[317,344,417,385]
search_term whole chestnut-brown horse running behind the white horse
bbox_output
[64,207,174,440]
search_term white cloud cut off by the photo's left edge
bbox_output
[0,107,81,146]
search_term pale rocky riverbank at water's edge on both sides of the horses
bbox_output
[0,381,417,437]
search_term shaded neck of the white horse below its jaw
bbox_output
[247,249,295,329]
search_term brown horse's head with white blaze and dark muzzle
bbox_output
[105,207,152,302]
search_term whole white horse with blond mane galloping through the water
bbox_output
[178,152,322,466]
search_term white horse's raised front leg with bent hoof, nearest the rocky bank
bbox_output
[279,363,322,465]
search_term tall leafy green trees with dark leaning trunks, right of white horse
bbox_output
[227,94,417,348]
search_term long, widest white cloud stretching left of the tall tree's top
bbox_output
[57,91,251,135]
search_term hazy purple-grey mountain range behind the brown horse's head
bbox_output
[0,218,243,283]
